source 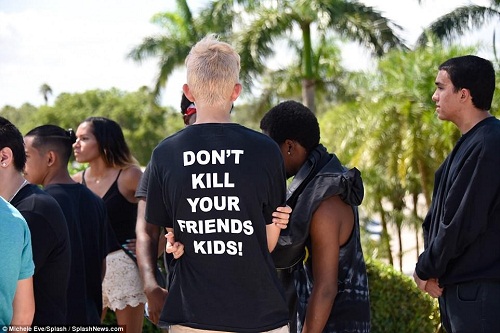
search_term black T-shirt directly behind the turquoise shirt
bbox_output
[11,184,71,325]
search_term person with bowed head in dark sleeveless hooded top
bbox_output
[260,101,370,333]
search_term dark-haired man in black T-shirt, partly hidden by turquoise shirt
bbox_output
[0,117,71,325]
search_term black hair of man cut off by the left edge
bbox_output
[0,117,26,172]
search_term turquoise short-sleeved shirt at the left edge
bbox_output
[0,197,35,327]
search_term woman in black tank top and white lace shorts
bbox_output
[73,117,146,332]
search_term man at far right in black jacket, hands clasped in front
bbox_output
[413,55,500,333]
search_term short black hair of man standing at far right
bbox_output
[439,55,495,111]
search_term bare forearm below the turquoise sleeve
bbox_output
[11,277,35,327]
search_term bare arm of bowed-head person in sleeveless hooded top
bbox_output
[302,196,354,333]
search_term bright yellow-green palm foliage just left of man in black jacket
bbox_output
[320,43,474,269]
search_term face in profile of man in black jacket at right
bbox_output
[432,70,461,123]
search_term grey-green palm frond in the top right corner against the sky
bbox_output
[417,0,500,45]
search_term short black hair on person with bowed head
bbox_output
[260,100,320,153]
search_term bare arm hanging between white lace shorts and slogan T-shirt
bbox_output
[136,199,167,324]
